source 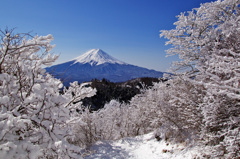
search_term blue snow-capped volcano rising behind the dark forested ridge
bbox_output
[45,49,163,85]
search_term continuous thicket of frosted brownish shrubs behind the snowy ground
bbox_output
[72,77,202,147]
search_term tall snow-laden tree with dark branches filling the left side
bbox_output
[0,29,88,159]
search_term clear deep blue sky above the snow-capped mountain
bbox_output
[0,0,212,71]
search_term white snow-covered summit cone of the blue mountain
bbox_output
[74,49,126,65]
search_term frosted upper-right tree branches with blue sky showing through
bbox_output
[160,0,239,76]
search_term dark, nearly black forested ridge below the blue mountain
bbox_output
[82,77,161,111]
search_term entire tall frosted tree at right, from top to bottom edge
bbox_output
[161,0,240,158]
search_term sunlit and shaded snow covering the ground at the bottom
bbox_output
[84,133,201,159]
